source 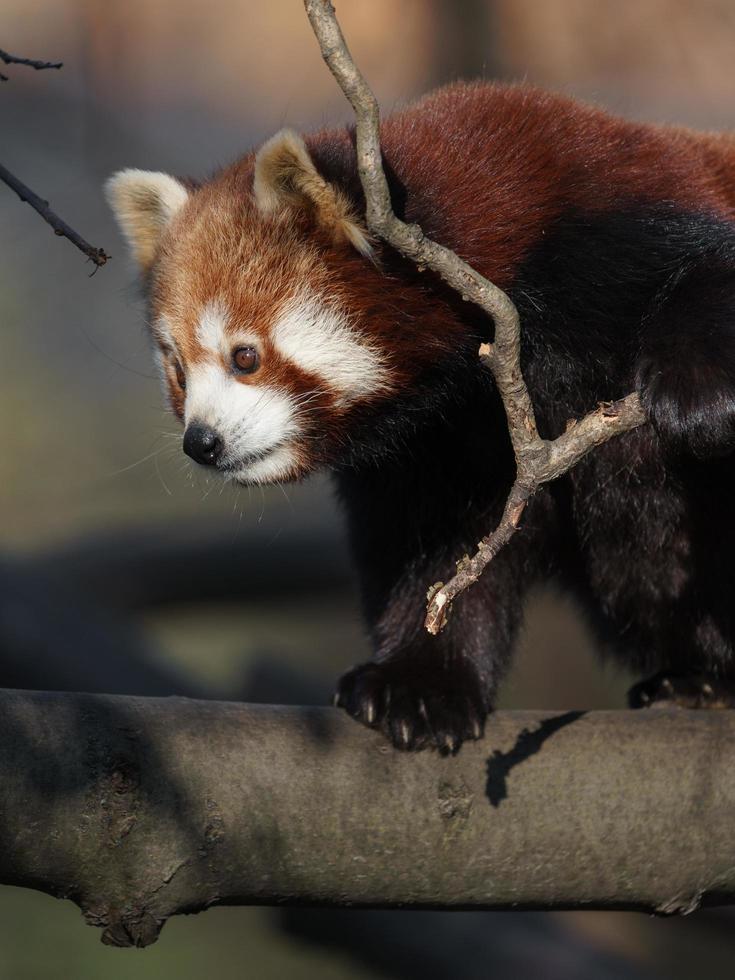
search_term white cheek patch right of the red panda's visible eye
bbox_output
[271,292,389,404]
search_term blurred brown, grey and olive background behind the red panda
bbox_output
[0,0,735,980]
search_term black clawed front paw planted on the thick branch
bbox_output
[334,659,488,755]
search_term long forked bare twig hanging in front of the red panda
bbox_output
[304,0,645,633]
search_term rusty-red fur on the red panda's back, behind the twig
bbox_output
[313,83,735,286]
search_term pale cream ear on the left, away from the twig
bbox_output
[105,170,189,272]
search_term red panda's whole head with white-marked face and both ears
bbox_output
[107,131,468,483]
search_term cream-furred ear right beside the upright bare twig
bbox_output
[253,129,373,256]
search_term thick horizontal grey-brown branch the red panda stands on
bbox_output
[0,691,735,945]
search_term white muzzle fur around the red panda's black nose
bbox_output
[185,364,299,482]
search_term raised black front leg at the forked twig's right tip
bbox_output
[636,245,735,459]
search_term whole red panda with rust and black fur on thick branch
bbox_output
[107,83,735,752]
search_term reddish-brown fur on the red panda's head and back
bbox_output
[150,83,735,486]
